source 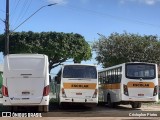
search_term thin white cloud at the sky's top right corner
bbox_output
[120,0,160,5]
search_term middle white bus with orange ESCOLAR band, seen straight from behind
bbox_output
[55,64,98,106]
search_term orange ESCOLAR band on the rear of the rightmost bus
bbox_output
[127,82,155,88]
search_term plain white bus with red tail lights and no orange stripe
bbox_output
[2,54,49,112]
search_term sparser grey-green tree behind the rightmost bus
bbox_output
[93,32,160,67]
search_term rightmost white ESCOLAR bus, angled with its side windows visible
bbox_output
[98,62,158,108]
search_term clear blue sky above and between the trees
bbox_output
[0,0,160,74]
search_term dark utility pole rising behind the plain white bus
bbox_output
[5,0,9,55]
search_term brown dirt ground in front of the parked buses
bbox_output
[0,104,160,120]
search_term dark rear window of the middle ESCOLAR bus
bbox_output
[63,65,97,79]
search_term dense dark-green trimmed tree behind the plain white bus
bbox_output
[0,31,92,70]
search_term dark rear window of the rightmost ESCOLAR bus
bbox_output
[126,63,156,79]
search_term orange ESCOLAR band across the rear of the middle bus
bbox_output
[63,83,97,89]
